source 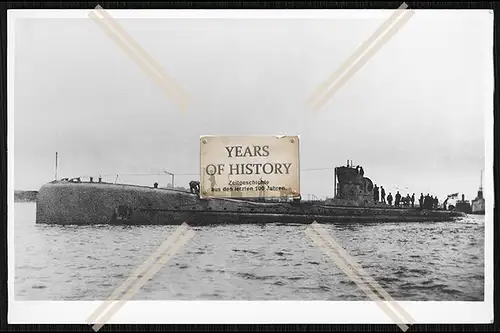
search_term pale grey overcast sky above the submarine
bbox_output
[10,11,493,199]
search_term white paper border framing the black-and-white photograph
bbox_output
[7,9,494,324]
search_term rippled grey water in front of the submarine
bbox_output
[15,203,484,301]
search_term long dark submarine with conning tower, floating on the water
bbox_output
[36,163,465,226]
